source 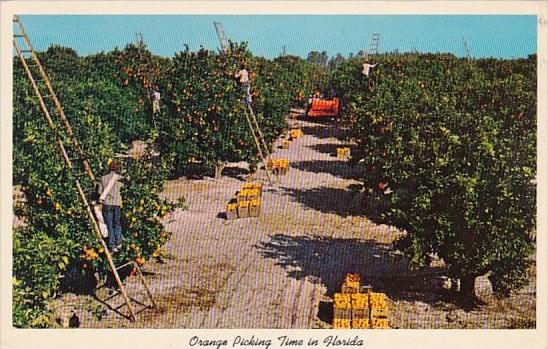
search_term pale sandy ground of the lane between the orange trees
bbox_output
[49,116,536,328]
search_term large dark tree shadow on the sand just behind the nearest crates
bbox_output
[256,234,448,323]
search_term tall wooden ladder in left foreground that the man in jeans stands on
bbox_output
[13,16,158,321]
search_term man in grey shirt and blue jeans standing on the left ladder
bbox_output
[98,161,124,252]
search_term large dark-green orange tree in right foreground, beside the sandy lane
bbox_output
[333,54,536,299]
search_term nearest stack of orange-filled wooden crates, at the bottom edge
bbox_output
[333,274,388,329]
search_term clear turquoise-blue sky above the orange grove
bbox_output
[21,15,537,58]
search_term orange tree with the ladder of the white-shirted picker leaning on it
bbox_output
[159,43,304,175]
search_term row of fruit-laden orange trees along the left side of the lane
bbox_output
[13,43,328,327]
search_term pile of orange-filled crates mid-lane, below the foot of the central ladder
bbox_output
[226,183,263,220]
